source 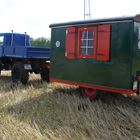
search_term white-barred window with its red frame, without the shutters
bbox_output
[78,27,96,58]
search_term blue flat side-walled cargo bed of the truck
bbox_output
[0,46,50,59]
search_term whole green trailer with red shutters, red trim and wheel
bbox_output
[50,15,140,96]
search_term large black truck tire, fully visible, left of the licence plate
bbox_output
[11,62,29,85]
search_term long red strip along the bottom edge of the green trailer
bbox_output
[50,78,136,95]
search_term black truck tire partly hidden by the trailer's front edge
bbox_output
[40,69,50,82]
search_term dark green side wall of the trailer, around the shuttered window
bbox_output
[51,17,137,90]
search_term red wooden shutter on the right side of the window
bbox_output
[96,25,110,61]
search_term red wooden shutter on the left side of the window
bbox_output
[65,27,76,59]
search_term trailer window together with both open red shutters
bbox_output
[65,24,110,62]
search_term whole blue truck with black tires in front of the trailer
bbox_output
[0,32,51,84]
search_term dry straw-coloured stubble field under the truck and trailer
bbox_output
[0,72,140,140]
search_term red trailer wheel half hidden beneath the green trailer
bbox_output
[80,87,97,100]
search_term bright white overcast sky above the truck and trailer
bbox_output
[0,0,140,38]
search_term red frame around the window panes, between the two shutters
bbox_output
[77,27,97,58]
